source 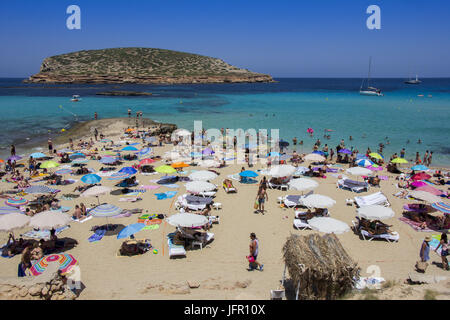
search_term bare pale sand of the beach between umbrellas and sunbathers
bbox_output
[0,119,449,300]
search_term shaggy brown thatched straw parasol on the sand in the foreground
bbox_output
[283,234,360,300]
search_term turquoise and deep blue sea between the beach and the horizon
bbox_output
[0,78,450,166]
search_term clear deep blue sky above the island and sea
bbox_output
[0,0,450,77]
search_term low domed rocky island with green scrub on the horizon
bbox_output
[24,48,273,84]
